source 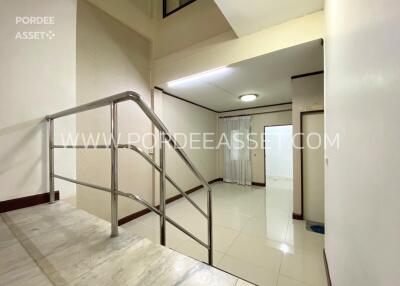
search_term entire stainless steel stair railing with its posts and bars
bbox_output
[46,91,213,266]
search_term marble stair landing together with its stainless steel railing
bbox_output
[0,91,260,286]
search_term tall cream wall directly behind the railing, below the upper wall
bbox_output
[77,0,152,219]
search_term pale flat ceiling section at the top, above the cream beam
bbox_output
[215,0,324,37]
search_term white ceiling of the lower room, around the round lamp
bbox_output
[159,40,323,112]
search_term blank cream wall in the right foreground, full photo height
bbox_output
[325,0,400,286]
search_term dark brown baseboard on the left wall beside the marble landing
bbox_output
[0,191,60,213]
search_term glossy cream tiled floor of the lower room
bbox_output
[123,180,326,286]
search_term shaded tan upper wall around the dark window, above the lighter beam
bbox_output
[79,0,232,58]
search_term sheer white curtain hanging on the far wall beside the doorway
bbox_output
[223,116,251,185]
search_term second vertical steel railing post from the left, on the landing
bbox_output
[110,102,118,237]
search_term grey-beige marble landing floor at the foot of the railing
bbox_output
[0,202,251,286]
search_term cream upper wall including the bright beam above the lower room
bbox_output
[78,0,325,86]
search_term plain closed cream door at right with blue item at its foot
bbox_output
[302,113,325,223]
